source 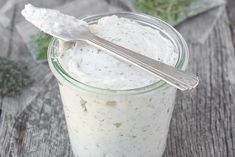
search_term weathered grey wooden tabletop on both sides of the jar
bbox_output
[0,0,235,157]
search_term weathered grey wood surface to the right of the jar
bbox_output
[165,11,235,157]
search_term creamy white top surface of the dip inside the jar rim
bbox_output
[63,16,178,90]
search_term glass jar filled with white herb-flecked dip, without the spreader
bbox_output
[48,12,188,157]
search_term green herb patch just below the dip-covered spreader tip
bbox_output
[29,32,52,60]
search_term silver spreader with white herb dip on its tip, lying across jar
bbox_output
[22,4,199,91]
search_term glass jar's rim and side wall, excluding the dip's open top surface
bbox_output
[48,12,189,157]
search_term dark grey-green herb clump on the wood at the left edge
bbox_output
[0,58,32,97]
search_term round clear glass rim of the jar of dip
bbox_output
[47,12,189,95]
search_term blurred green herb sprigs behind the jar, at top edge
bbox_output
[134,0,192,23]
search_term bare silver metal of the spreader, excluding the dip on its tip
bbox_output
[56,26,199,91]
